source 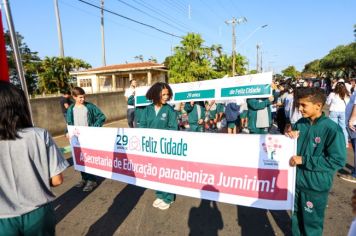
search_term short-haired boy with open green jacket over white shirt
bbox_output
[67,87,106,192]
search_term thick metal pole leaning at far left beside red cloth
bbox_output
[4,0,33,124]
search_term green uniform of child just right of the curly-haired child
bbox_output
[184,102,205,132]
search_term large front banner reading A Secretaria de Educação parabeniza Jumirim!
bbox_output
[68,126,296,210]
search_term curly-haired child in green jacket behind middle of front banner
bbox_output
[140,82,178,210]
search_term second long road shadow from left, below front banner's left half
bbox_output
[86,184,146,236]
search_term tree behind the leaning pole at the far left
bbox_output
[4,31,41,94]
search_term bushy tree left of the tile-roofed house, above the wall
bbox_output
[38,57,91,93]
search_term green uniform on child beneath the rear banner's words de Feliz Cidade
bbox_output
[246,98,272,134]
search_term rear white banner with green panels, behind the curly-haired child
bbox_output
[135,72,272,106]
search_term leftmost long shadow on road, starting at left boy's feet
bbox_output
[53,177,105,224]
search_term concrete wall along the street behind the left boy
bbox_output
[30,91,127,136]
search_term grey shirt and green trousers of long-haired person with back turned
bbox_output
[0,127,69,235]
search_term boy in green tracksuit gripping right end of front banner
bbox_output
[286,88,346,235]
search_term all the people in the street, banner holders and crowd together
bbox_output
[0,76,356,235]
